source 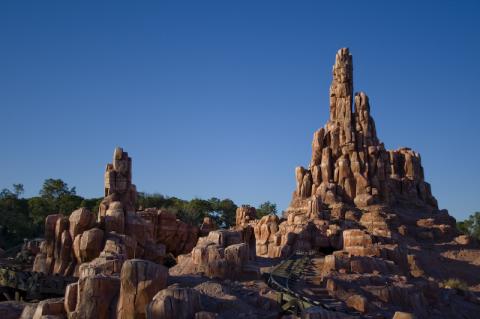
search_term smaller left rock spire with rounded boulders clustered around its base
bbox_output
[33,148,166,276]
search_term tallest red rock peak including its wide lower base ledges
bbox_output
[255,48,455,257]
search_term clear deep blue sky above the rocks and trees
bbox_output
[0,0,480,218]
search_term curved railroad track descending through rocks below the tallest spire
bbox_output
[267,252,361,318]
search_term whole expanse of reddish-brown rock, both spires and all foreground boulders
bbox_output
[13,49,480,319]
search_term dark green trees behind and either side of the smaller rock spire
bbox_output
[0,179,277,250]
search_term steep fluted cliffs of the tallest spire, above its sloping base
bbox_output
[287,48,438,218]
